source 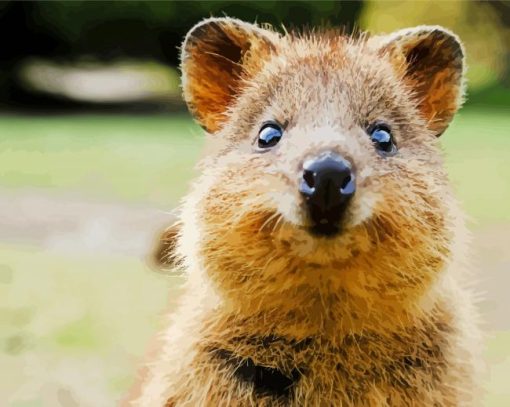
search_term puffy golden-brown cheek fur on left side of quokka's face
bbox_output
[195,160,307,305]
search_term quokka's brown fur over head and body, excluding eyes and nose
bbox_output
[123,18,478,406]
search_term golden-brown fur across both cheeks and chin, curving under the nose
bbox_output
[183,150,450,316]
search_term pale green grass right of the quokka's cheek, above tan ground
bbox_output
[442,109,510,224]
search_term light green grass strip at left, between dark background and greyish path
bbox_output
[0,116,202,206]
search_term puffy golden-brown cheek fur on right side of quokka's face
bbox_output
[332,163,451,310]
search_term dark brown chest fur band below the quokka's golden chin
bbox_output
[203,327,448,405]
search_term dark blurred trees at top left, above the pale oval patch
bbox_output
[0,0,363,110]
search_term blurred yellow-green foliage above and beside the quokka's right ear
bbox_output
[360,0,510,94]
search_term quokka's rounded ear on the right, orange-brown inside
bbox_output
[382,26,465,136]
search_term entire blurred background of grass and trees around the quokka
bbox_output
[0,1,510,407]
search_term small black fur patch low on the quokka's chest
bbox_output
[214,349,301,398]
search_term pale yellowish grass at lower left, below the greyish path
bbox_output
[0,245,181,406]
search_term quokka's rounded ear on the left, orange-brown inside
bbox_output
[181,17,278,133]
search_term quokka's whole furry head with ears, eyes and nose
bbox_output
[177,18,463,314]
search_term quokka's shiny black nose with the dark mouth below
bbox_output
[299,152,356,236]
